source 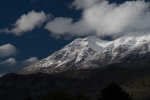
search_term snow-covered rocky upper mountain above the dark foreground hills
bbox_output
[18,32,150,74]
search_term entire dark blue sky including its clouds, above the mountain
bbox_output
[0,0,150,75]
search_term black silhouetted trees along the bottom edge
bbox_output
[24,83,132,100]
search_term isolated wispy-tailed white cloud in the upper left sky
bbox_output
[0,10,51,35]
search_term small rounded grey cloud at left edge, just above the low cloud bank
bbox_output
[0,44,17,58]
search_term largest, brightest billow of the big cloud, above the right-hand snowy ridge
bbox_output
[84,1,150,36]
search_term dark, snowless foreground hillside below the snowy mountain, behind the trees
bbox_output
[0,66,150,100]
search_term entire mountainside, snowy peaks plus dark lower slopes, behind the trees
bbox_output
[0,32,150,100]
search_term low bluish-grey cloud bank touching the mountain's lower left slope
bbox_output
[0,57,39,76]
